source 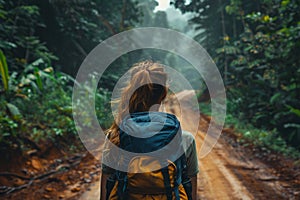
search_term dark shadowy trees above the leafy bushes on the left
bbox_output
[0,0,140,75]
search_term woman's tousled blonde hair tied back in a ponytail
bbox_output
[107,60,167,145]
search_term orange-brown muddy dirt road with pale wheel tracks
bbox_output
[80,91,300,200]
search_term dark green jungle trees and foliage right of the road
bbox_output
[173,0,300,149]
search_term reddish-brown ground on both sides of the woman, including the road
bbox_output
[0,91,300,200]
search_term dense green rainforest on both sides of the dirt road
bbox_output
[0,0,300,180]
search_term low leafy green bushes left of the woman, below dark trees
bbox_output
[0,59,111,151]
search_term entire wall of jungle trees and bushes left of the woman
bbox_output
[0,0,140,152]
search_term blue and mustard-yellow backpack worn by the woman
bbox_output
[106,112,192,200]
